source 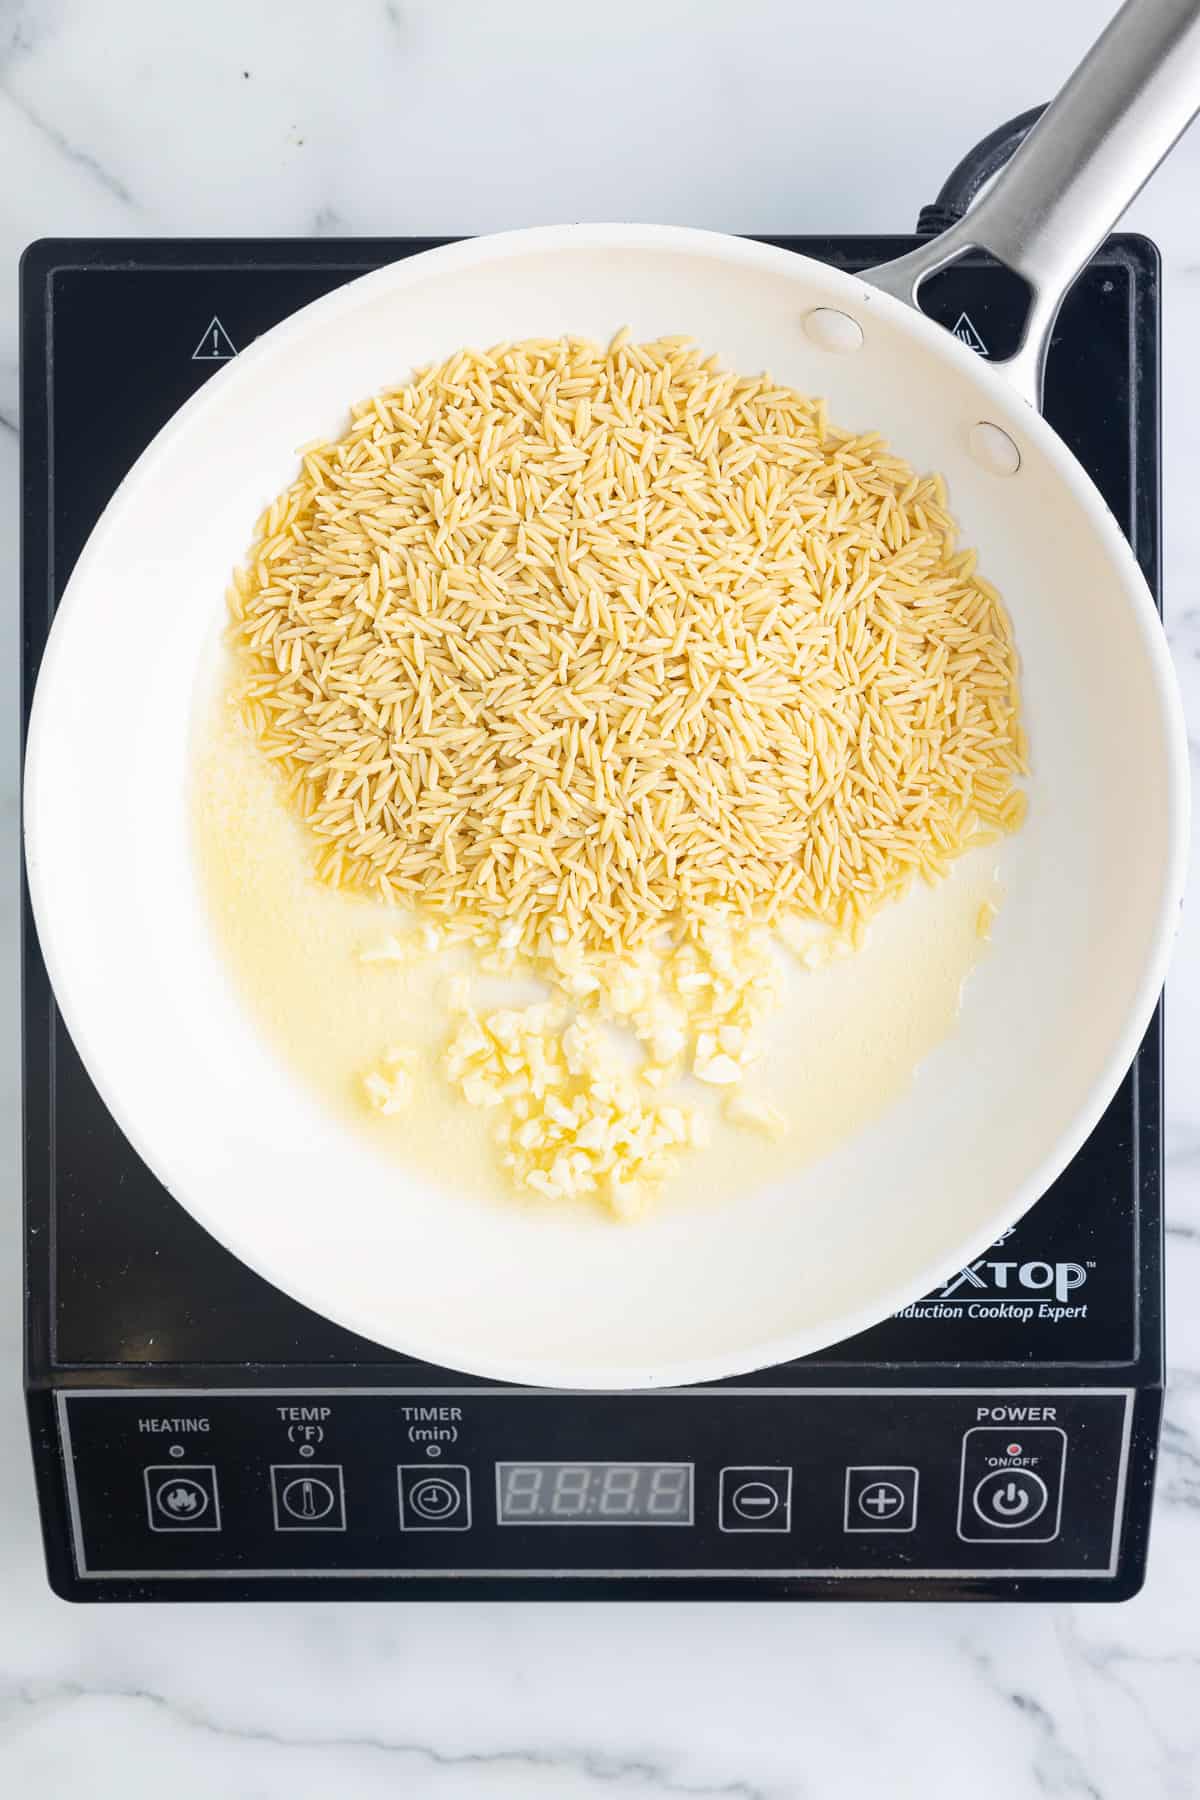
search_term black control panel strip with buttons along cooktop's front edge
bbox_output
[58,1388,1133,1580]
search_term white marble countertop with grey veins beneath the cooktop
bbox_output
[0,0,1200,1800]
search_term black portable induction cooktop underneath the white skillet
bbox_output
[22,236,1162,1600]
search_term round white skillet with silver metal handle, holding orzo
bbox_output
[25,0,1200,1388]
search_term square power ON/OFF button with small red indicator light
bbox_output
[959,1426,1067,1544]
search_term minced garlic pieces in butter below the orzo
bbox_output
[360,918,805,1217]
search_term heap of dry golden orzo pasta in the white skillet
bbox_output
[232,333,1024,949]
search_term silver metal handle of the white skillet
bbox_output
[862,0,1200,409]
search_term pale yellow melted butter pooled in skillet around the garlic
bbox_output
[193,682,999,1204]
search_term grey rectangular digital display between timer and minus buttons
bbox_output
[497,1463,693,1525]
